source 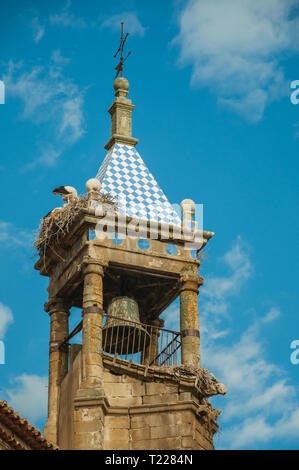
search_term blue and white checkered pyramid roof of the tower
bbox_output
[96,144,181,225]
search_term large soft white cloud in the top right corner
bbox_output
[174,0,299,122]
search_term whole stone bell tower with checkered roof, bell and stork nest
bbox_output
[35,77,225,450]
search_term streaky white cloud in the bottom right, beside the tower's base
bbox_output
[209,323,299,449]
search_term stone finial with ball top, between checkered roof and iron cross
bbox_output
[105,77,138,150]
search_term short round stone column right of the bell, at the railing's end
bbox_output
[180,278,202,367]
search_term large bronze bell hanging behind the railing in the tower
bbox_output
[103,297,150,356]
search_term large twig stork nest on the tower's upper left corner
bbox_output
[34,194,116,256]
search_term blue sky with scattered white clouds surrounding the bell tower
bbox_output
[0,0,299,449]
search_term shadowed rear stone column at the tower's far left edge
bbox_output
[44,299,69,444]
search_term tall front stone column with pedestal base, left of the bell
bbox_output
[73,259,107,450]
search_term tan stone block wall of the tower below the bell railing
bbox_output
[58,353,215,450]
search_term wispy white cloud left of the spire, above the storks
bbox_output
[4,57,85,169]
